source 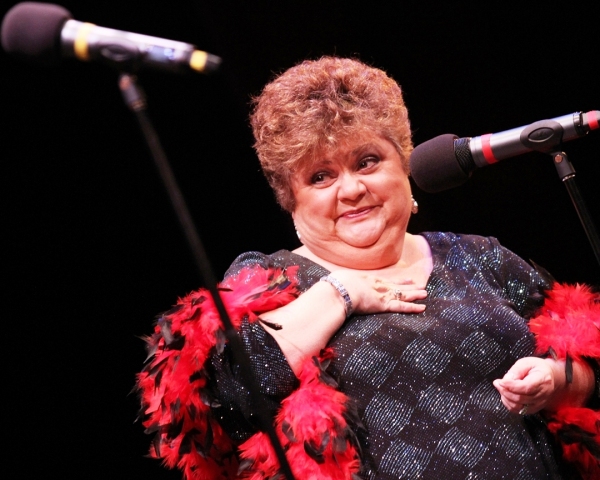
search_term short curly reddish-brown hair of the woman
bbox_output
[250,57,413,212]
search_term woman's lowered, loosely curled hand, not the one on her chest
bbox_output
[494,357,565,415]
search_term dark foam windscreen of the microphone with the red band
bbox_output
[410,133,469,193]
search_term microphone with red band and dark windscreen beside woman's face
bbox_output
[410,110,600,193]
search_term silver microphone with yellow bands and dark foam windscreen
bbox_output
[2,2,221,73]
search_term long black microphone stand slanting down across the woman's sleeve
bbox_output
[119,73,294,480]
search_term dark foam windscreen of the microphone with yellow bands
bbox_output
[2,2,71,65]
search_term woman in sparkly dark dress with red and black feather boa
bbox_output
[139,57,600,479]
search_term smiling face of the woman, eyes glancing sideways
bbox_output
[292,134,412,269]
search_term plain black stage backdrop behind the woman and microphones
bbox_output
[0,0,600,479]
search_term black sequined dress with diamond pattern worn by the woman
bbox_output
[210,233,563,480]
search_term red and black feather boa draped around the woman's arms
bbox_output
[137,267,600,480]
